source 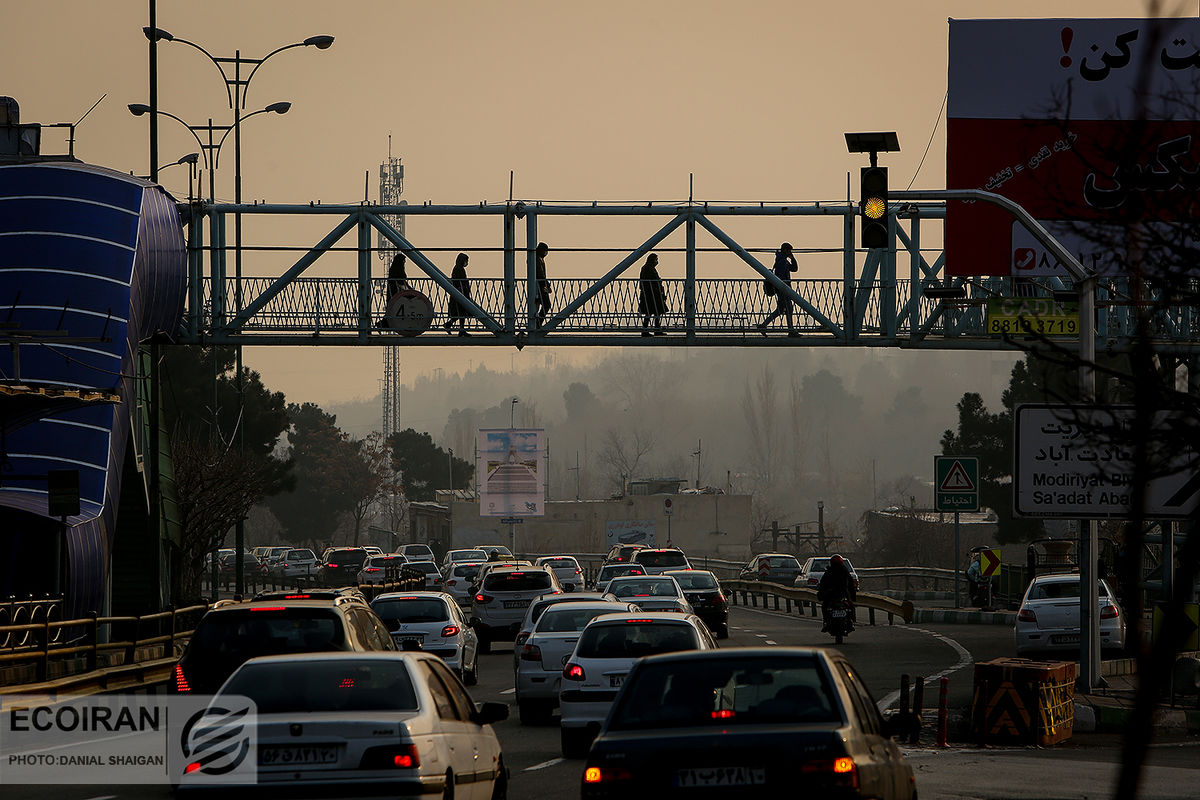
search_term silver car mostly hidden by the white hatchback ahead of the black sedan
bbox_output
[515,595,638,724]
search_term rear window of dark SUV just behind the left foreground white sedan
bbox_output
[188,607,346,661]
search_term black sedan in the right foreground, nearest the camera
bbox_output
[581,647,917,800]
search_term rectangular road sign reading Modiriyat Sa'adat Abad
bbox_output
[1013,404,1200,519]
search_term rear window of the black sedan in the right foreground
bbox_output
[608,656,840,730]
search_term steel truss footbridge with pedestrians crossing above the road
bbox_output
[175,192,1200,355]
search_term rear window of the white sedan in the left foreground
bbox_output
[223,658,416,714]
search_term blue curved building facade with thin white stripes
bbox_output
[0,162,187,616]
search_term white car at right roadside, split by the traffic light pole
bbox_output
[1013,572,1126,656]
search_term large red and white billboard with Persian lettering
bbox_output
[946,19,1200,277]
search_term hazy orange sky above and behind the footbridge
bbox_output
[7,0,1152,404]
